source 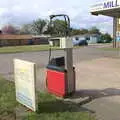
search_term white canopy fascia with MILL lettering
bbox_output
[91,0,120,12]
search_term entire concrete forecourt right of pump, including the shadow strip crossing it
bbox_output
[76,58,120,120]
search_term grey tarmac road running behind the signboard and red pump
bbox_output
[0,46,118,79]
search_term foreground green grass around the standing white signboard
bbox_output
[0,77,95,120]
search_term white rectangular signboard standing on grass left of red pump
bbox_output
[14,59,36,111]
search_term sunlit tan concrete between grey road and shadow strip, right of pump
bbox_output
[75,58,120,90]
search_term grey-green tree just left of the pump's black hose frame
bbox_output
[32,19,47,34]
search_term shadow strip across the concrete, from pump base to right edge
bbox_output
[69,88,120,105]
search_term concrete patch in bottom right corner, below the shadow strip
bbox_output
[84,96,120,120]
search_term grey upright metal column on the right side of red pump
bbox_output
[65,48,75,93]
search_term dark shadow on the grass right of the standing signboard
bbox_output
[38,100,95,113]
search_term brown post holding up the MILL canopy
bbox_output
[113,17,117,48]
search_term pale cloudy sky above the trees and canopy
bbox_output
[0,0,112,33]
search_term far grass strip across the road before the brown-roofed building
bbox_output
[0,45,59,53]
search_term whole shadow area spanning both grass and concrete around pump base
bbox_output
[35,88,120,113]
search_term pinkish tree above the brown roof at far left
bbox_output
[2,25,19,34]
